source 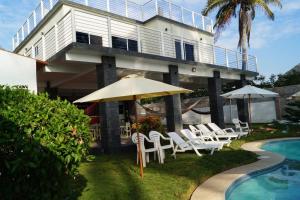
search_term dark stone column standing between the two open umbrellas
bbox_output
[208,71,225,128]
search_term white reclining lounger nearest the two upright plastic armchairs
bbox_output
[167,132,215,158]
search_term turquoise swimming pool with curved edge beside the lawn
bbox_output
[226,140,300,200]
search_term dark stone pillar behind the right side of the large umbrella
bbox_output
[163,65,182,132]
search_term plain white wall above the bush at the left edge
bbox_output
[0,50,37,93]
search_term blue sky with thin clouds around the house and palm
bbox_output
[0,0,300,77]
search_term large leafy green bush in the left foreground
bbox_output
[0,86,90,199]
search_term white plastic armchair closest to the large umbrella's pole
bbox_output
[131,133,159,167]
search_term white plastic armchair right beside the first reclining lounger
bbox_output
[149,131,174,164]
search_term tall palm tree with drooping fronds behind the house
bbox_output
[202,0,282,70]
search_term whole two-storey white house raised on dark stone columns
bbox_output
[12,0,257,151]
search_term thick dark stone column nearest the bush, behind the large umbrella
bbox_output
[96,56,121,154]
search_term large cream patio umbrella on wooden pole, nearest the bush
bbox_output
[74,74,192,177]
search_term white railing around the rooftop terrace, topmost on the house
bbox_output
[12,0,213,50]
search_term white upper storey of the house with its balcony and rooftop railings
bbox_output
[13,0,257,72]
